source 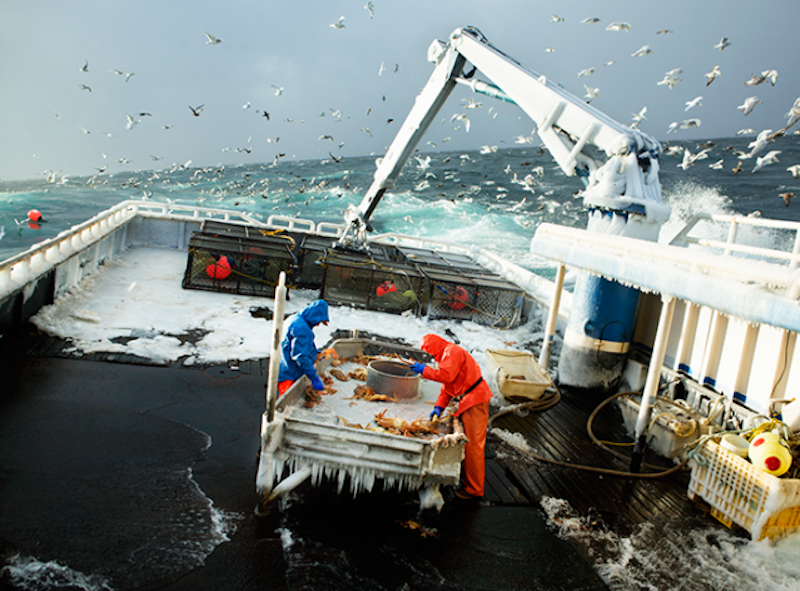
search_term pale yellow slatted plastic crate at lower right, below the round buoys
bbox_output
[687,440,800,540]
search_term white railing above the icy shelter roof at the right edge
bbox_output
[669,213,800,269]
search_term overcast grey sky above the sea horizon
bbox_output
[0,0,800,180]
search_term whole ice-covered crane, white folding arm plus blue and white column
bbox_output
[340,27,670,388]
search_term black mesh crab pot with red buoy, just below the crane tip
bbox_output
[322,247,425,314]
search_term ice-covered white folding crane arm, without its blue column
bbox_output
[339,27,669,245]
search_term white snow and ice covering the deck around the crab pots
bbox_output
[26,247,542,408]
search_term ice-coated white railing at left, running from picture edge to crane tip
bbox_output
[0,201,344,300]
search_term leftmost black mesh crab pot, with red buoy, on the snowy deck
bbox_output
[182,224,295,296]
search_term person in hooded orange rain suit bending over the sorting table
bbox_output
[411,334,492,499]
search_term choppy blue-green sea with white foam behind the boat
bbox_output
[0,134,800,270]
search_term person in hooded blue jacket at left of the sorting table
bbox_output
[278,300,329,395]
